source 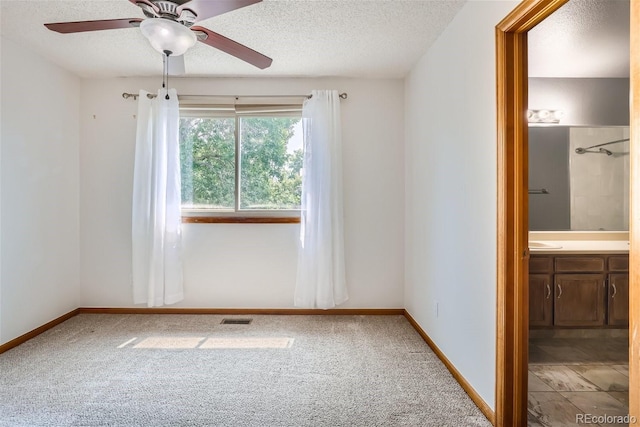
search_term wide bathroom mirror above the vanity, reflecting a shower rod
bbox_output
[529,126,629,231]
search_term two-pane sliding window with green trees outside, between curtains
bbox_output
[180,106,303,221]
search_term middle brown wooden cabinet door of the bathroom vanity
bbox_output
[553,274,605,326]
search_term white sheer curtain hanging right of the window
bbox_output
[294,90,349,309]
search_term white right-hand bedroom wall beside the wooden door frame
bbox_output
[405,1,518,408]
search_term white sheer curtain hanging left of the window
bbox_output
[132,89,183,307]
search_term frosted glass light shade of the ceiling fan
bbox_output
[140,18,197,56]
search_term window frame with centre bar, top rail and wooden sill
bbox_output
[180,103,302,224]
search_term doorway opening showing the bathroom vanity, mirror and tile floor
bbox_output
[527,0,630,427]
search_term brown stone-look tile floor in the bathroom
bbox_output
[528,329,629,427]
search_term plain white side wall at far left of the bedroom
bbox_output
[0,38,80,344]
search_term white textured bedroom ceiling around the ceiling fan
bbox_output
[0,0,464,78]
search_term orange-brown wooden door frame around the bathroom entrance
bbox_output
[496,0,640,426]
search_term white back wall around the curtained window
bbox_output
[80,77,404,308]
